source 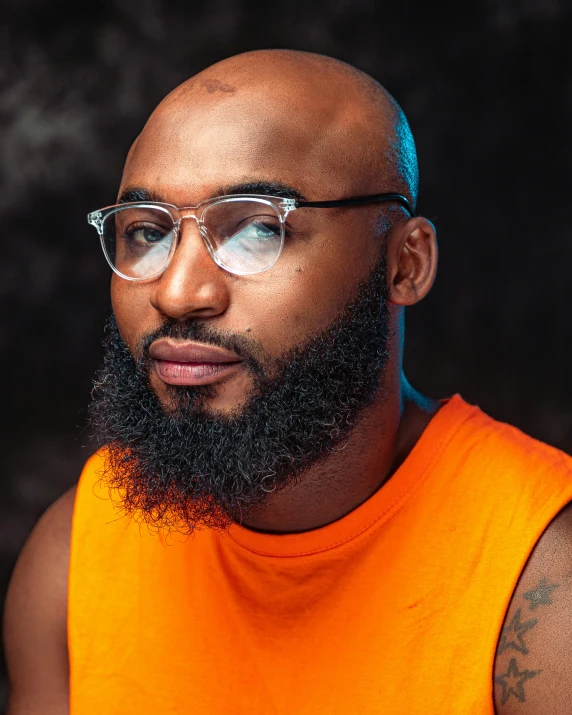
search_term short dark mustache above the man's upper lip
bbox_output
[137,318,270,377]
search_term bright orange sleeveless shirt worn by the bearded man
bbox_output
[68,396,572,715]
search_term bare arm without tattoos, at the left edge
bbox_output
[4,487,75,715]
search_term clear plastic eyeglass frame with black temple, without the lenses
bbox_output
[87,193,414,281]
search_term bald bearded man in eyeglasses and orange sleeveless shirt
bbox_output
[5,51,572,715]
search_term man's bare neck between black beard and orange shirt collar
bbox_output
[242,373,439,533]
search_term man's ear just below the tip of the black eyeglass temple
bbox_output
[387,216,437,305]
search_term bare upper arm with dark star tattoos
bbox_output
[494,505,572,715]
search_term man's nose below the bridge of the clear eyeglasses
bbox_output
[150,215,230,320]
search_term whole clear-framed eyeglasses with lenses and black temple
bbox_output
[87,194,413,281]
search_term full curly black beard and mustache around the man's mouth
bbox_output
[89,251,390,533]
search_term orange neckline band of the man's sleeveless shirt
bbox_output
[228,394,478,558]
